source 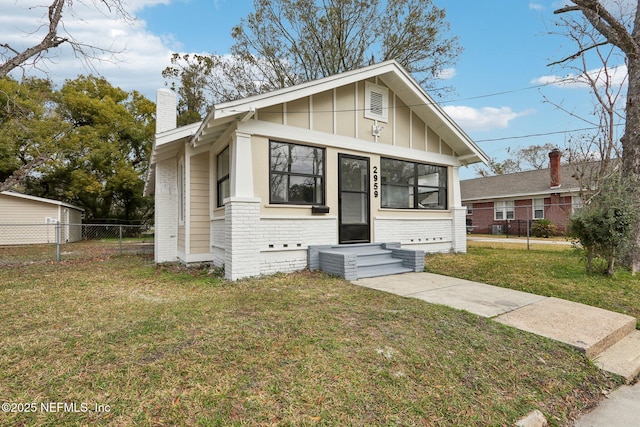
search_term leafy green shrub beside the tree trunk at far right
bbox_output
[568,173,639,275]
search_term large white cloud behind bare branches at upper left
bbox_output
[0,0,179,100]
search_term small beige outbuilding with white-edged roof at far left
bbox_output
[0,191,84,245]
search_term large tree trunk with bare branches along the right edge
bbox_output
[555,0,640,273]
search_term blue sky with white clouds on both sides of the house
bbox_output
[0,0,628,179]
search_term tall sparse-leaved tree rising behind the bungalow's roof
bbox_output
[164,0,461,108]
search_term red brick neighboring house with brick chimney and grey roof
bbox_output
[460,149,582,235]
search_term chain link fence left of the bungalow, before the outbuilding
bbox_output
[0,223,153,267]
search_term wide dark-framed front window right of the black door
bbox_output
[380,158,447,209]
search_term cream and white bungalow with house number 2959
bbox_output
[146,60,487,280]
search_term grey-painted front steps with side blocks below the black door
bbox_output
[309,242,425,280]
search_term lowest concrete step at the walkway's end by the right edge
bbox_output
[593,330,640,383]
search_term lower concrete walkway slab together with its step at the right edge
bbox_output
[494,298,640,383]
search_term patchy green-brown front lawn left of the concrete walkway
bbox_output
[0,257,620,426]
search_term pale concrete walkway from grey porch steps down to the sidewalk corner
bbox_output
[353,273,640,427]
